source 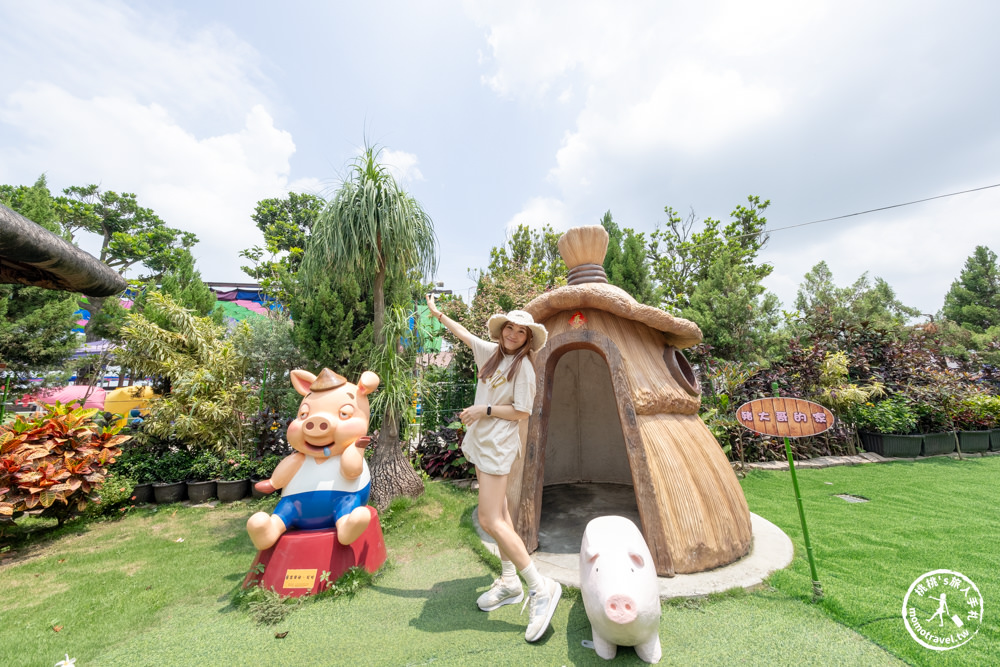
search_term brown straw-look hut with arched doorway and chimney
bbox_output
[508,226,751,576]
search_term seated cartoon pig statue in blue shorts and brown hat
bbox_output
[247,368,379,551]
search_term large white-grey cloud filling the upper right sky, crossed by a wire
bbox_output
[469,0,1000,312]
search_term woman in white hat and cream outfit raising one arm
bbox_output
[427,294,562,642]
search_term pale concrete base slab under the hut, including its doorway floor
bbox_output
[472,484,794,599]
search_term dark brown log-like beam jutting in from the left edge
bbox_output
[0,204,128,297]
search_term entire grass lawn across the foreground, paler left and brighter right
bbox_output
[0,457,1000,667]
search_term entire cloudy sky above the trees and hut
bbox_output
[0,0,1000,314]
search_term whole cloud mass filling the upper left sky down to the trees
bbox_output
[0,2,298,282]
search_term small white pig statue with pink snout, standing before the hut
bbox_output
[580,516,660,663]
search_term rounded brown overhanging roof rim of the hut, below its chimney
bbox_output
[524,282,701,349]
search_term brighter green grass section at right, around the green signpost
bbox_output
[743,457,1000,665]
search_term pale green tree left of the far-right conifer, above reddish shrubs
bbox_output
[795,261,920,328]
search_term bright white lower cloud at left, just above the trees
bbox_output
[0,85,295,281]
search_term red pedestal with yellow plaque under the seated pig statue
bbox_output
[243,506,386,597]
